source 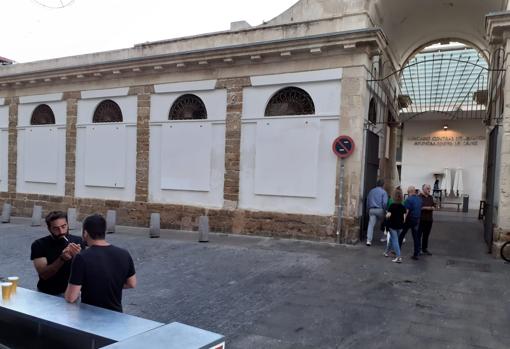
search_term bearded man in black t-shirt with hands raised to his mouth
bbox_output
[30,211,84,295]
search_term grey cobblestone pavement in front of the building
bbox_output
[0,211,510,349]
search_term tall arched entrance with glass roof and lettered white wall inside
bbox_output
[365,39,505,250]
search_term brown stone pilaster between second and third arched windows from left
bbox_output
[129,85,154,202]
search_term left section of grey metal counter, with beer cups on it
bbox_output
[0,287,164,348]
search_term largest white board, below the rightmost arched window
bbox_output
[254,118,320,198]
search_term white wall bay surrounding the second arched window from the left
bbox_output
[75,94,138,201]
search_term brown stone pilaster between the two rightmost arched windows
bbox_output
[216,77,251,209]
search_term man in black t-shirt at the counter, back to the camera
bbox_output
[65,214,136,312]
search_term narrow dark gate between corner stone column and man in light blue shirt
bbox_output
[360,130,379,240]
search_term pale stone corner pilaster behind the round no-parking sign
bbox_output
[335,63,369,243]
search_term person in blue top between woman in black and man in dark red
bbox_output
[398,186,422,260]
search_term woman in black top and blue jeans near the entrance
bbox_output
[384,189,407,263]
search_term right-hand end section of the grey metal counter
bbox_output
[101,322,225,349]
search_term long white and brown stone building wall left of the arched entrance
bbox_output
[0,46,369,242]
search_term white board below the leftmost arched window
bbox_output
[23,127,60,184]
